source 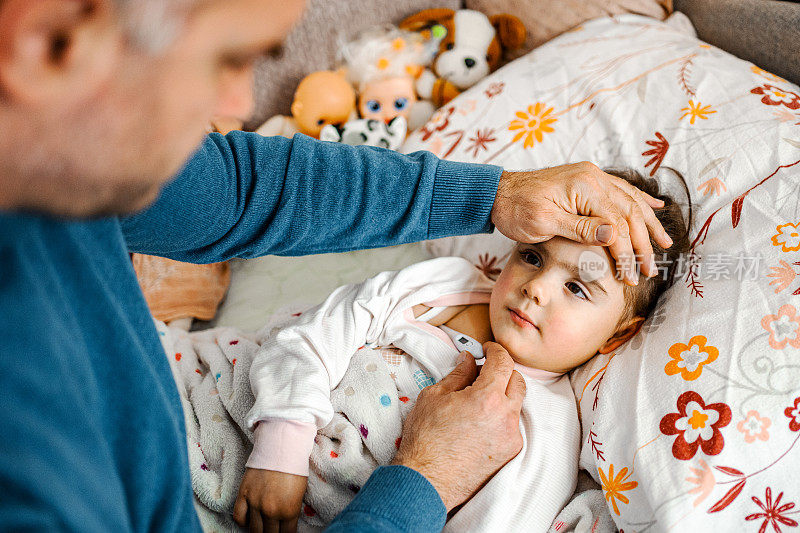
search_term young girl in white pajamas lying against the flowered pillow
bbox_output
[237,171,691,531]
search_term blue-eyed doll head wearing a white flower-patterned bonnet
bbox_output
[339,27,435,123]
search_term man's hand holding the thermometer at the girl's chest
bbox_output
[392,342,525,511]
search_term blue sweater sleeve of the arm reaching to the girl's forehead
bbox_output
[121,132,502,263]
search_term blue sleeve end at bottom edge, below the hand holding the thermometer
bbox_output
[325,465,447,533]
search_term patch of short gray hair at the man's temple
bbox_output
[114,0,200,53]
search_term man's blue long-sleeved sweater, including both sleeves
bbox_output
[0,133,500,532]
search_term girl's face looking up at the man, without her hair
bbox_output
[489,237,640,372]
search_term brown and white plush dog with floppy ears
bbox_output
[400,9,526,107]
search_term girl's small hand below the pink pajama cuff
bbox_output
[233,468,308,533]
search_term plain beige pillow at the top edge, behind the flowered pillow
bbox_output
[465,0,672,57]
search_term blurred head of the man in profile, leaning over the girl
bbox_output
[0,0,304,216]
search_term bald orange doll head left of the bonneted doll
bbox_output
[292,70,356,137]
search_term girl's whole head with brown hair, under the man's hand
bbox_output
[489,171,691,373]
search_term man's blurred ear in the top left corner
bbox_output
[0,0,122,106]
